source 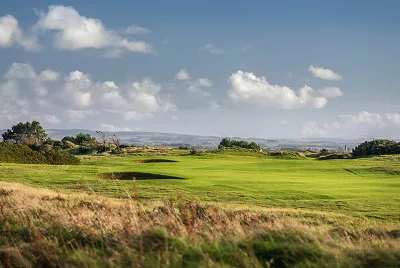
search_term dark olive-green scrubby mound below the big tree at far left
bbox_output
[0,142,80,165]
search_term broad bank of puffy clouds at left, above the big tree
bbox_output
[0,63,177,127]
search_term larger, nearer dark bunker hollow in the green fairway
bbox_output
[97,172,184,181]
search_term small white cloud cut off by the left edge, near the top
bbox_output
[0,15,40,51]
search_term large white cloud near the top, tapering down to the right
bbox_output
[35,6,154,56]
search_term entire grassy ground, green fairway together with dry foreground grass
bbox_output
[0,154,400,267]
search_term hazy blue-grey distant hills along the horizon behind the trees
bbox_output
[0,129,365,150]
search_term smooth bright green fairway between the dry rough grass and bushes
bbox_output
[0,155,400,222]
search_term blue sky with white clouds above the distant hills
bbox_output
[0,0,400,138]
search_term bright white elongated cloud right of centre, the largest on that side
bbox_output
[228,71,337,109]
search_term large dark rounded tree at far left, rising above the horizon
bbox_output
[2,121,47,145]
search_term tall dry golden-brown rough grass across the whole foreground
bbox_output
[0,182,400,267]
